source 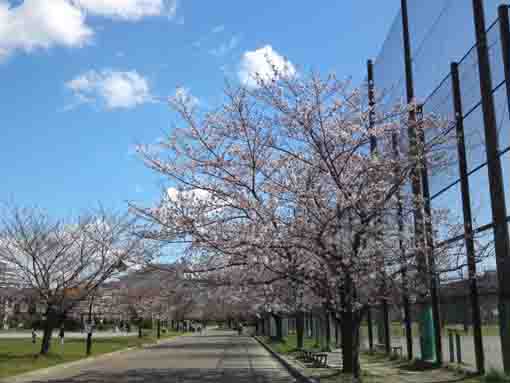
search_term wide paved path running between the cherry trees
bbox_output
[21,330,294,383]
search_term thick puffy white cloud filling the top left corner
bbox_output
[0,0,94,58]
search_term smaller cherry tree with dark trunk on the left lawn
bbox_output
[0,206,148,354]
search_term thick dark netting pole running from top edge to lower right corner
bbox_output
[473,0,510,373]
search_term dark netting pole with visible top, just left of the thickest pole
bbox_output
[451,63,485,374]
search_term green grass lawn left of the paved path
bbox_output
[0,330,179,378]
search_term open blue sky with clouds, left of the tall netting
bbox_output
[0,0,400,214]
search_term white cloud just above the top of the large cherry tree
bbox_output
[237,45,296,87]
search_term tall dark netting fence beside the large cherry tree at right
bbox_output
[362,0,510,370]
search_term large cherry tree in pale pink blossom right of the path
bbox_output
[131,67,470,377]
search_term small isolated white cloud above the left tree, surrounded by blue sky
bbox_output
[66,70,153,109]
